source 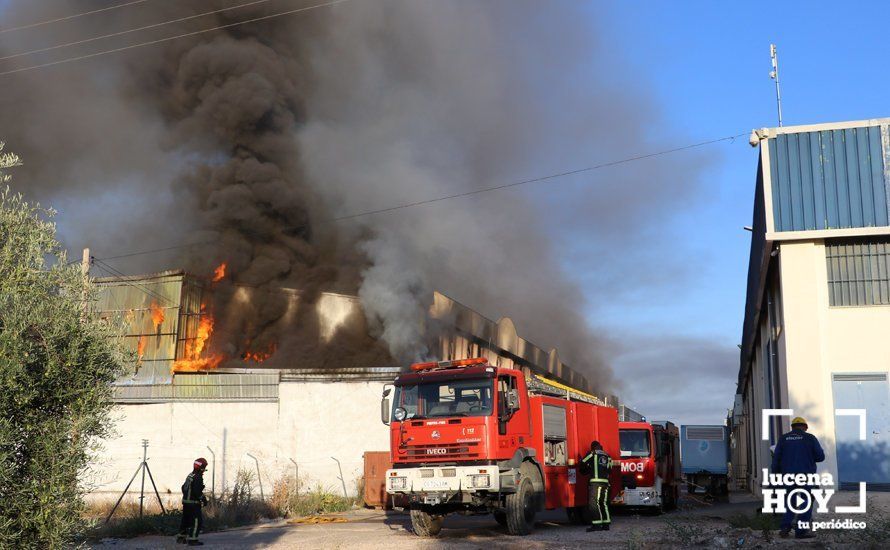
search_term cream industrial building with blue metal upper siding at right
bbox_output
[730,119,890,492]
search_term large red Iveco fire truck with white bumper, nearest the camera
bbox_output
[381,358,620,536]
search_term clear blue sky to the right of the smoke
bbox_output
[568,1,890,422]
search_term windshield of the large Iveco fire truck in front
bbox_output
[393,378,494,418]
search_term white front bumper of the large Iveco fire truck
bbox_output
[386,466,500,499]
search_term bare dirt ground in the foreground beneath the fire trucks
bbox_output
[94,493,890,550]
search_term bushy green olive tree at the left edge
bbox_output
[0,150,122,548]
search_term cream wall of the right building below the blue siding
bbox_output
[744,240,890,492]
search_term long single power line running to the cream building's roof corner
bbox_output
[97,132,747,261]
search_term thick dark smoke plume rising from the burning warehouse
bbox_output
[0,0,712,396]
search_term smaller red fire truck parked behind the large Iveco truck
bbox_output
[612,422,680,513]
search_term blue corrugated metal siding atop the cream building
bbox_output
[769,126,890,231]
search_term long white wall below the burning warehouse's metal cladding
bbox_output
[85,382,389,501]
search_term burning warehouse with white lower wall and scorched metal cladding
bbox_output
[86,271,615,499]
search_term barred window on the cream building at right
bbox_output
[825,237,890,306]
